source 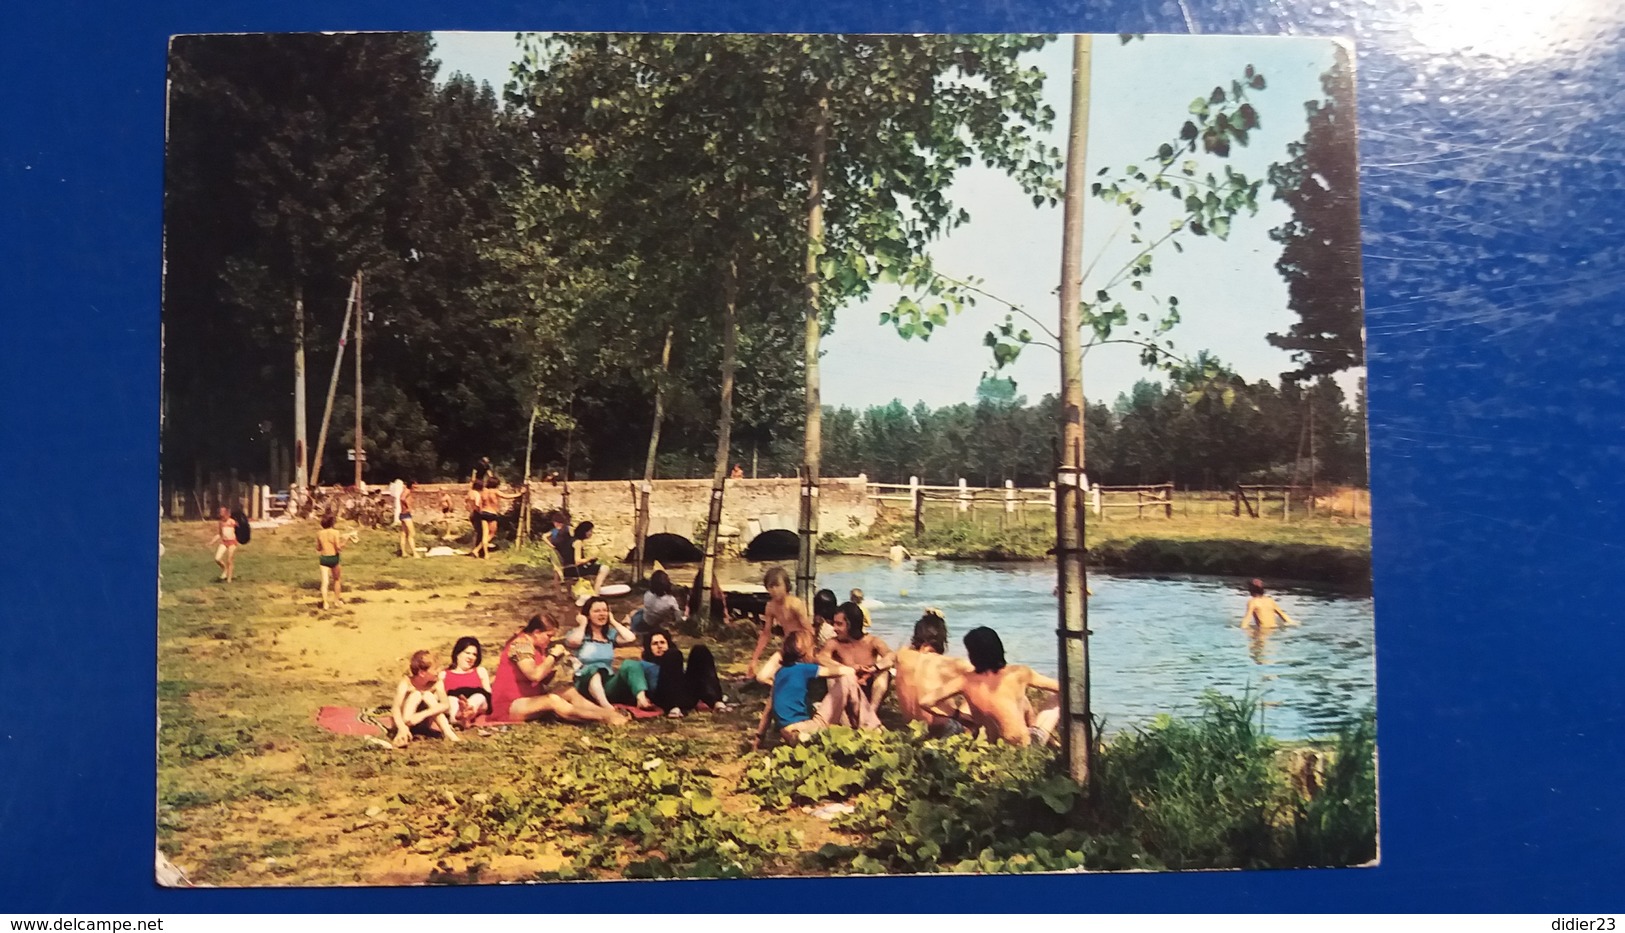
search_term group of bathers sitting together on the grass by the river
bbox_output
[392,567,1060,746]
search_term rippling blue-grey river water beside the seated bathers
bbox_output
[722,556,1376,740]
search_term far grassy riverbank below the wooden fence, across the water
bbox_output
[819,499,1372,584]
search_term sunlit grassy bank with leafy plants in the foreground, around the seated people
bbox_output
[158,525,1375,884]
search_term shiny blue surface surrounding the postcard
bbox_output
[0,0,1625,913]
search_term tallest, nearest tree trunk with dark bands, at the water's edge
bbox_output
[1055,36,1094,783]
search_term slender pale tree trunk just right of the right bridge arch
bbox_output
[796,83,829,603]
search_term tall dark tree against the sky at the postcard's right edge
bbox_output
[1269,46,1365,379]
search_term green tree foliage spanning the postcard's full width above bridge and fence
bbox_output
[163,34,1363,503]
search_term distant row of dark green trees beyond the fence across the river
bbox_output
[824,377,1367,489]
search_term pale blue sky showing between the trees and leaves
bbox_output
[436,33,1360,408]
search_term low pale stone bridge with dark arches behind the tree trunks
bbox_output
[419,476,876,561]
